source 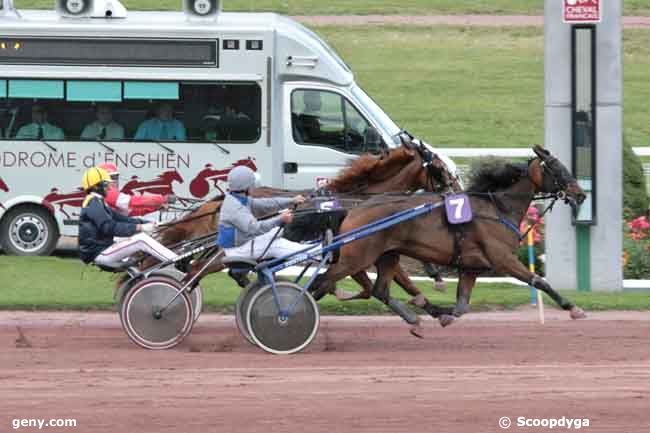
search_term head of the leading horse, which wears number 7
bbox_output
[529,146,587,209]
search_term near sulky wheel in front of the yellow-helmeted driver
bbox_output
[120,277,194,349]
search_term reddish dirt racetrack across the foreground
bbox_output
[0,310,650,433]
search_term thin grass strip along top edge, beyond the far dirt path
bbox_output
[15,0,650,15]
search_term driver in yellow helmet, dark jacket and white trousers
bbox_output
[79,167,177,268]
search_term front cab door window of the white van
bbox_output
[291,89,375,153]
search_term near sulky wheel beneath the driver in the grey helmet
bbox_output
[246,281,320,355]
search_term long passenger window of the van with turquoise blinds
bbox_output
[0,79,262,143]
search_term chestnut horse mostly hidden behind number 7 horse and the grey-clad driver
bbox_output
[143,138,460,309]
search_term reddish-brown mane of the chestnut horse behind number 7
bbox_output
[328,147,415,192]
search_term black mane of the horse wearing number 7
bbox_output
[467,156,528,193]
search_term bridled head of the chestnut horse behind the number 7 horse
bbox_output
[400,134,462,191]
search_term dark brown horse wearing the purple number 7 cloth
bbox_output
[312,146,585,334]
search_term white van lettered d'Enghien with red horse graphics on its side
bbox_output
[0,0,399,255]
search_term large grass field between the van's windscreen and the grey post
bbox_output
[316,26,544,147]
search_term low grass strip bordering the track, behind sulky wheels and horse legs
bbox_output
[0,256,650,314]
